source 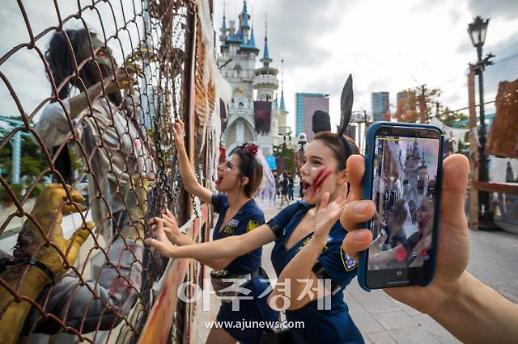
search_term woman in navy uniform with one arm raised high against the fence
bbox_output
[152,122,279,344]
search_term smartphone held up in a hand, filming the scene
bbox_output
[358,122,444,290]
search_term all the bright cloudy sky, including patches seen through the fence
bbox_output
[0,0,518,132]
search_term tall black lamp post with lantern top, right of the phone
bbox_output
[468,16,494,226]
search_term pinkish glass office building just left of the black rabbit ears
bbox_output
[295,93,329,142]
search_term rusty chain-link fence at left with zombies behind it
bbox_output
[0,0,219,342]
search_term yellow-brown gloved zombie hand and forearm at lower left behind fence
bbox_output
[0,184,94,343]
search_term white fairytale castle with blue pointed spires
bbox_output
[217,1,288,156]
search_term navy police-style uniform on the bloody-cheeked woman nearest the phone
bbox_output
[268,201,363,343]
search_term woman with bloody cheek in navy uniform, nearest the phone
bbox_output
[146,132,363,343]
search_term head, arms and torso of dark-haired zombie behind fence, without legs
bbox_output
[35,29,153,241]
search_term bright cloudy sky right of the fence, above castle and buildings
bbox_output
[215,0,518,125]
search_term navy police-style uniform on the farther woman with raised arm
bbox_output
[212,194,279,344]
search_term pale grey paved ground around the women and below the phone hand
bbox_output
[193,202,518,344]
